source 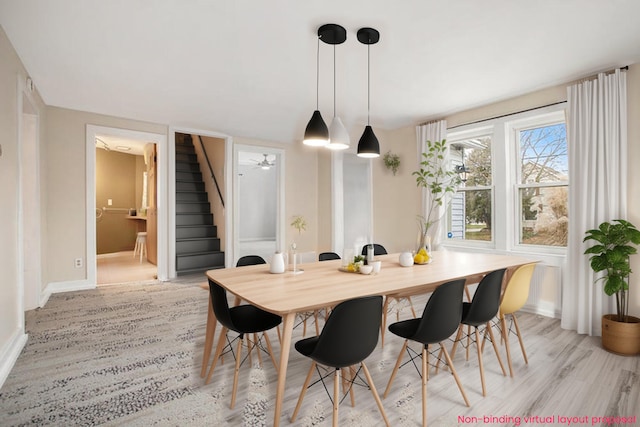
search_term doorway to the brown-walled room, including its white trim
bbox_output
[86,125,168,285]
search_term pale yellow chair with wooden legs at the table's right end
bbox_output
[492,263,536,377]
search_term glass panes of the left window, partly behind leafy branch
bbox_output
[448,135,493,241]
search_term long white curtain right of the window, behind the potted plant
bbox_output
[561,70,627,335]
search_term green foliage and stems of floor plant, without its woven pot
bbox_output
[583,219,640,322]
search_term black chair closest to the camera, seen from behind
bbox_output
[291,296,389,426]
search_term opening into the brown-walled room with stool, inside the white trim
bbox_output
[95,135,157,285]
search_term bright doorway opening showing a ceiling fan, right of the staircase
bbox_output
[233,145,286,264]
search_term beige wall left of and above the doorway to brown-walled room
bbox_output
[44,107,167,283]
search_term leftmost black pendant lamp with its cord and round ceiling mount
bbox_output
[303,24,347,147]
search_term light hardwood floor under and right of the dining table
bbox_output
[202,297,640,426]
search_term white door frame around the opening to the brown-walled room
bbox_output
[85,124,169,287]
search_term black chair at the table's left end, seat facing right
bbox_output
[206,279,282,409]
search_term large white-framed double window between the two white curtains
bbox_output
[442,104,569,254]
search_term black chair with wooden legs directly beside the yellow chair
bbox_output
[451,268,507,396]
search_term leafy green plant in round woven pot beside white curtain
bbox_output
[583,219,640,355]
